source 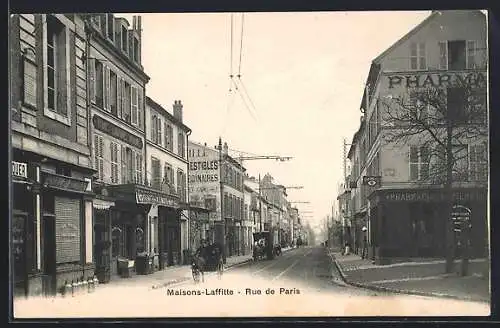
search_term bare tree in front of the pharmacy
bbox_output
[380,73,488,273]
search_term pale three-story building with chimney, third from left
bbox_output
[146,97,191,269]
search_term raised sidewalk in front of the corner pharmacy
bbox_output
[330,250,491,302]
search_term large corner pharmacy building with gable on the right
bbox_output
[349,10,488,262]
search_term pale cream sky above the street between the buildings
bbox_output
[119,11,430,231]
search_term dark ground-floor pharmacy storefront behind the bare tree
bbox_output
[370,188,488,263]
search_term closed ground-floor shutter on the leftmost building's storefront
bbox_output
[54,197,81,263]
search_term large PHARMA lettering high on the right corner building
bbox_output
[387,72,486,89]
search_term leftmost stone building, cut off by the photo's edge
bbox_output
[9,14,94,295]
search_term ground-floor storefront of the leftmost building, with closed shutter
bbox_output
[11,150,94,296]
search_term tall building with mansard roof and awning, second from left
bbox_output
[85,14,154,282]
